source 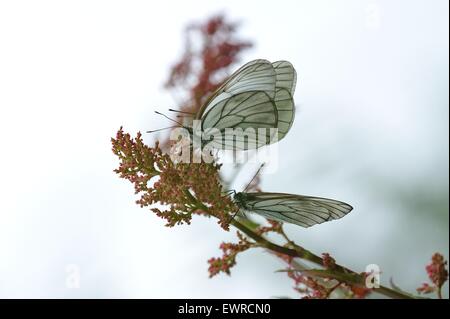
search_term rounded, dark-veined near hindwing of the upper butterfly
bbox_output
[202,91,278,150]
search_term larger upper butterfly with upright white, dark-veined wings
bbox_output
[188,60,297,150]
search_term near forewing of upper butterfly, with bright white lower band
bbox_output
[196,59,276,119]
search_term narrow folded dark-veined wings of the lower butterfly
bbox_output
[236,192,353,227]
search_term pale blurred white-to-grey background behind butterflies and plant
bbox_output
[0,0,449,298]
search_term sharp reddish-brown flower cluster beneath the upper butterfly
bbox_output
[111,128,237,230]
